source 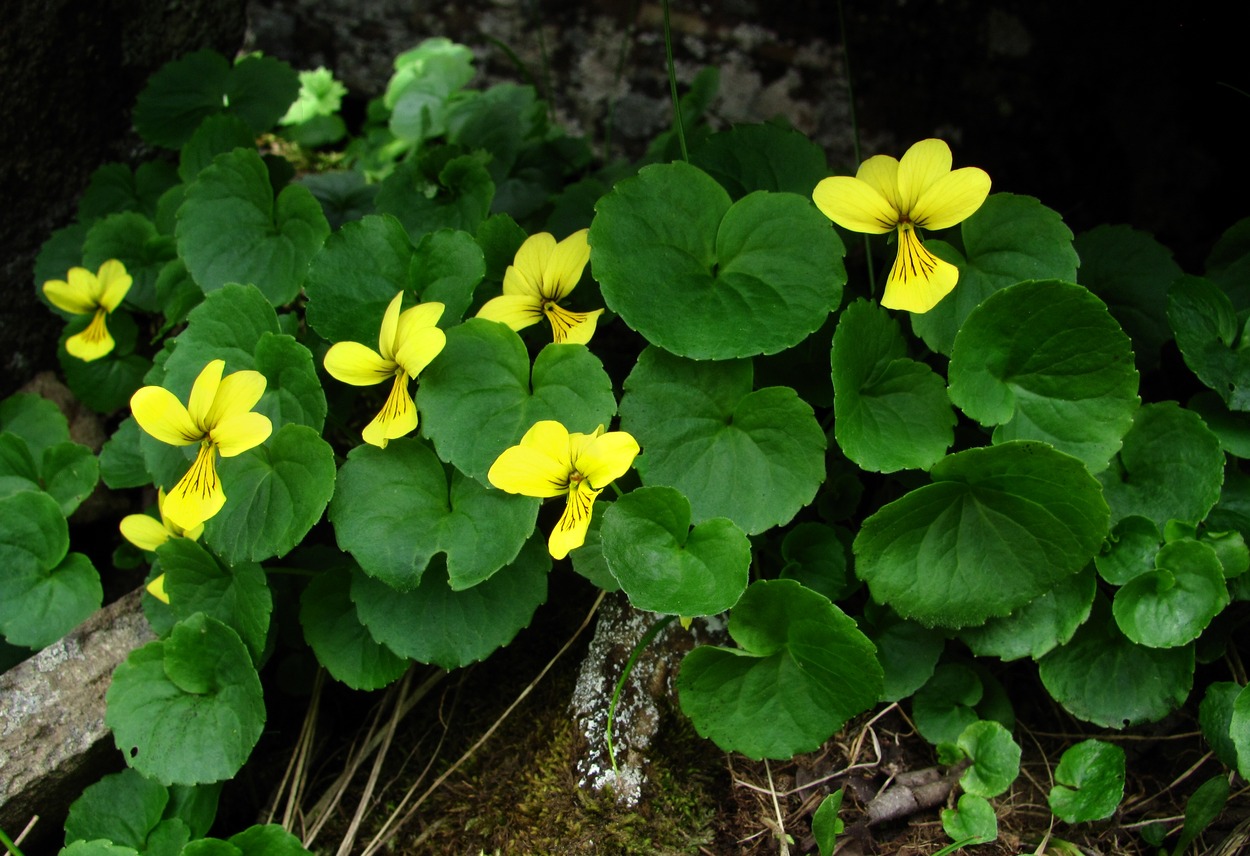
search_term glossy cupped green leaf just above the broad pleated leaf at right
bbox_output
[950,280,1140,472]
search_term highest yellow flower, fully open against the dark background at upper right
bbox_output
[811,140,990,312]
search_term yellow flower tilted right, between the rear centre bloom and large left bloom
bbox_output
[325,291,448,449]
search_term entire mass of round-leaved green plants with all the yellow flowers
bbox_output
[0,26,1250,856]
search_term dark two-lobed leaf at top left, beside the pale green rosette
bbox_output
[135,50,300,149]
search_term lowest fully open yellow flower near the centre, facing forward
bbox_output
[486,420,639,559]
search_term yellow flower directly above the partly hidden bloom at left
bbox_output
[130,360,274,531]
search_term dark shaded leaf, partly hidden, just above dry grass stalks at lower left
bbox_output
[300,559,409,690]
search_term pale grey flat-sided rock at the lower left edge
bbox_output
[0,589,155,852]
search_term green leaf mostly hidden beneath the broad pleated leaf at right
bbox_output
[959,567,1098,660]
